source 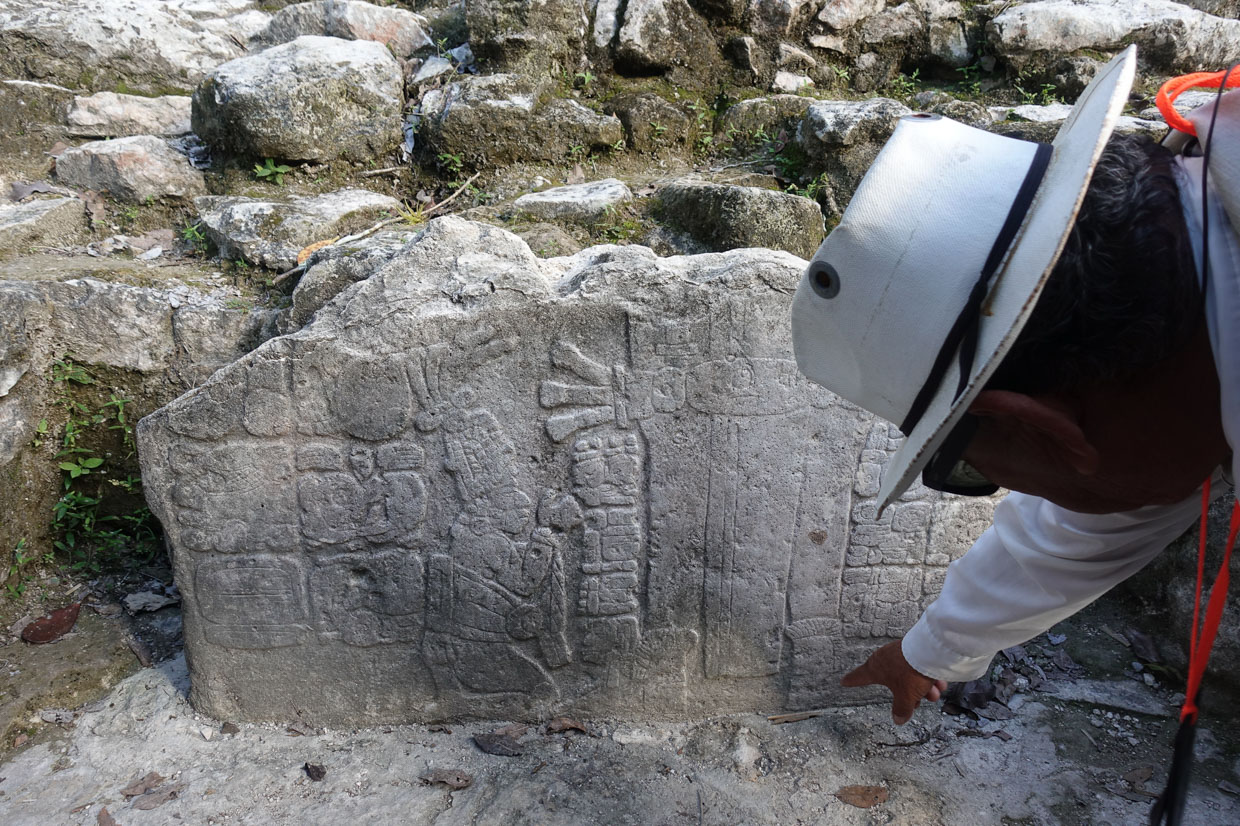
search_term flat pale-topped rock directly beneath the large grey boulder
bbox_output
[193,190,401,269]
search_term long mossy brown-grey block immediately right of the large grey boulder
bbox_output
[419,74,624,166]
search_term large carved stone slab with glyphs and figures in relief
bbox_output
[139,220,992,723]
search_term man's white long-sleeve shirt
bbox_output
[901,92,1240,681]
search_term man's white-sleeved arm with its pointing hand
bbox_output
[842,484,1226,723]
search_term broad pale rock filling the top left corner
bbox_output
[0,0,242,94]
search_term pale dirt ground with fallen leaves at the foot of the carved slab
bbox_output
[0,597,1240,826]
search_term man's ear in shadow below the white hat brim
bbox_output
[968,391,1100,476]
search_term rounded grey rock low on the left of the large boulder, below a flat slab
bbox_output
[56,135,207,203]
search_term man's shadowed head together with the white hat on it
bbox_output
[792,47,1221,510]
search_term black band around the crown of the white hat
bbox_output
[900,144,1052,435]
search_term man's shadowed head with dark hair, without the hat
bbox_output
[963,136,1228,512]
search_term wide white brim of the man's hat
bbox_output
[879,46,1137,512]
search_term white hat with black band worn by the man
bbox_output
[792,46,1136,510]
